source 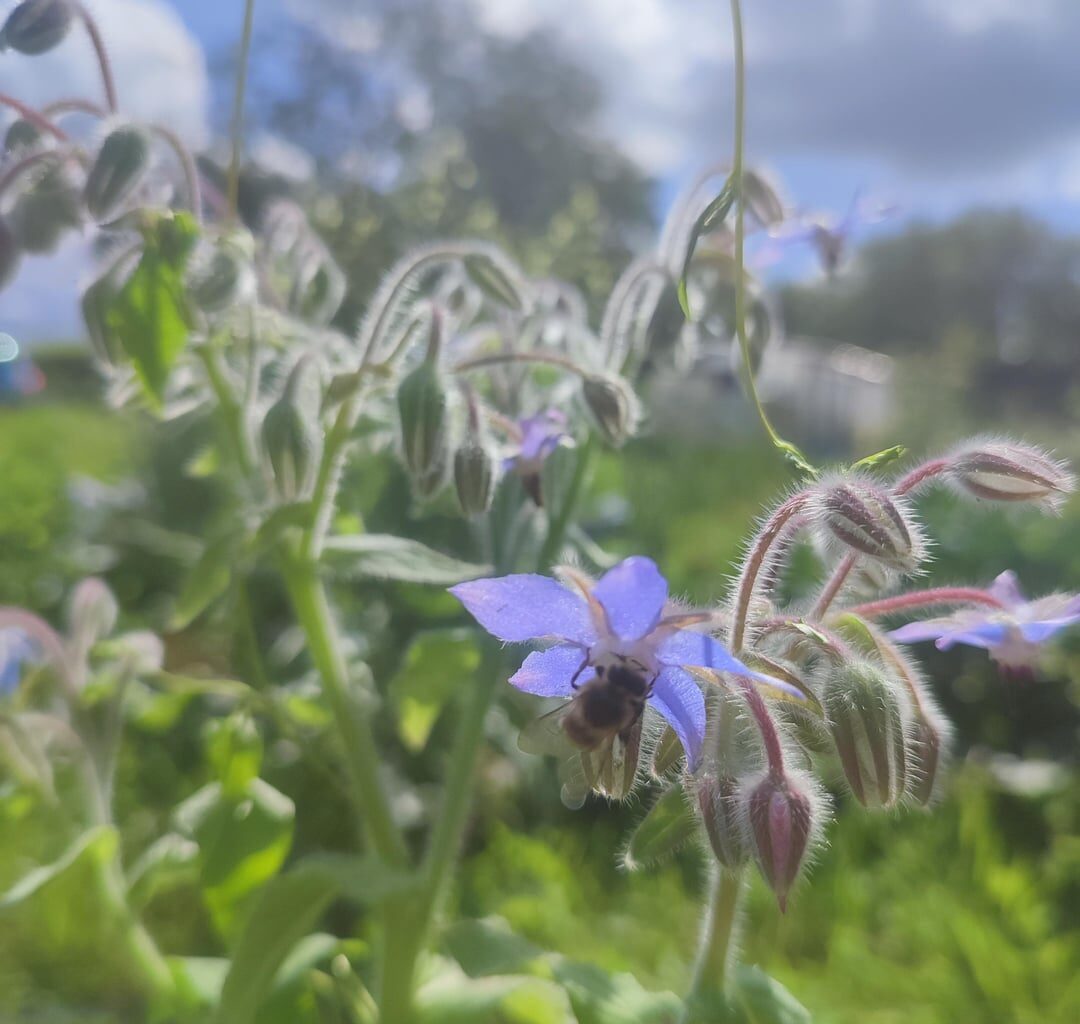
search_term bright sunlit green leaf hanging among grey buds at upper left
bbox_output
[105,212,199,408]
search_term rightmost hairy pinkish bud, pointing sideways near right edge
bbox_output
[947,441,1076,509]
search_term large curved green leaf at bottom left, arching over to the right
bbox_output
[216,854,413,1024]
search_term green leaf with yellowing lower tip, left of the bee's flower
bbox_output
[389,630,481,751]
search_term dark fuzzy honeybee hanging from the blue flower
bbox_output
[517,656,652,808]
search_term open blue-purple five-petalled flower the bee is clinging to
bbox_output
[450,556,801,767]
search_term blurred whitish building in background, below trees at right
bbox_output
[648,337,896,454]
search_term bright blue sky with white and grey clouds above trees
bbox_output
[0,0,1080,339]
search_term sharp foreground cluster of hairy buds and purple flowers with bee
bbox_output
[455,432,1080,907]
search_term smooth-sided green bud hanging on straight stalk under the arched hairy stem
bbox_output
[397,316,450,498]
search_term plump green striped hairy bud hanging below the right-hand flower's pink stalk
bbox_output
[822,661,908,807]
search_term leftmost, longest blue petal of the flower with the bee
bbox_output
[450,572,596,644]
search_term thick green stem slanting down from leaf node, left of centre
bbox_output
[282,558,408,864]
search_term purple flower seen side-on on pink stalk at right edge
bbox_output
[889,572,1080,671]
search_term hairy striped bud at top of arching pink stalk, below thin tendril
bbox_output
[814,480,924,572]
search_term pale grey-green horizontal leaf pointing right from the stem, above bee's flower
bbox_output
[323,534,491,587]
